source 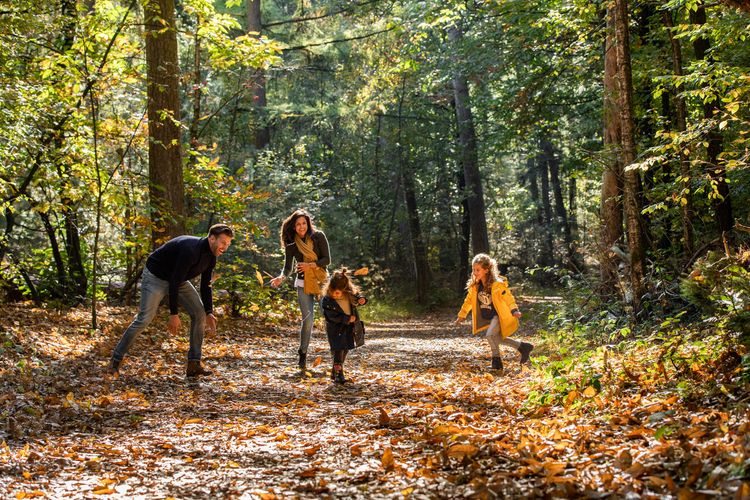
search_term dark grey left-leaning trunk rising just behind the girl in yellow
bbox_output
[448,26,490,255]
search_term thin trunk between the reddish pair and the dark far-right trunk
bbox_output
[662,11,694,259]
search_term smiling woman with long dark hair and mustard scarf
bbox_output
[271,209,331,370]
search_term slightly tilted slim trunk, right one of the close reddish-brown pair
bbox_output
[615,0,646,314]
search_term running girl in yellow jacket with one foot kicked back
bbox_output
[456,253,534,370]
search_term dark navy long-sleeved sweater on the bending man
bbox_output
[146,236,216,314]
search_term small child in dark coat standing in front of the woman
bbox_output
[320,267,367,384]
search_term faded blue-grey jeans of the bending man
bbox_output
[112,267,206,361]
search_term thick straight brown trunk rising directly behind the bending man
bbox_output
[144,0,185,246]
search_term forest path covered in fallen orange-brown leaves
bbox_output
[0,298,744,499]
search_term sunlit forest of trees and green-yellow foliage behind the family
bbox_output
[0,0,750,480]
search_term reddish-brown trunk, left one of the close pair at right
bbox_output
[599,5,623,300]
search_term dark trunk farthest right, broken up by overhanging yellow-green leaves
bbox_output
[690,2,734,237]
